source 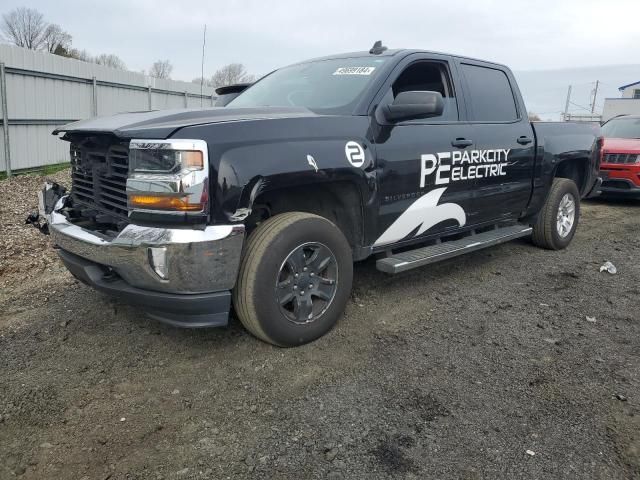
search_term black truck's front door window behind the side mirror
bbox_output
[391,62,458,123]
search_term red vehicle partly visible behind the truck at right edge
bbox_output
[600,115,640,198]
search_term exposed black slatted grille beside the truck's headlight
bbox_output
[71,139,129,219]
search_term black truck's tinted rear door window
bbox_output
[462,63,518,122]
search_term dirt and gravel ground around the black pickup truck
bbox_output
[0,173,640,480]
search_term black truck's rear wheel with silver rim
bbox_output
[531,178,580,250]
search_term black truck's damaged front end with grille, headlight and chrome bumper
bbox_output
[27,136,244,327]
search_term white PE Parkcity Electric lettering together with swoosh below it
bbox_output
[374,149,511,246]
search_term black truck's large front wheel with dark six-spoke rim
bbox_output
[233,212,353,347]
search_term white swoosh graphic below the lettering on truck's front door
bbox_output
[373,187,467,246]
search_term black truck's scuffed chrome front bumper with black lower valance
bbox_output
[43,197,244,327]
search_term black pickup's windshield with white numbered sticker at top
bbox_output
[228,57,386,114]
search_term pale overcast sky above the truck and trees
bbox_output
[0,0,640,80]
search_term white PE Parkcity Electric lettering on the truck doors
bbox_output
[420,148,511,188]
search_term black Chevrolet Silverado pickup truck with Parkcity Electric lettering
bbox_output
[40,43,600,346]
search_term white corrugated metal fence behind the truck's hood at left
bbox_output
[0,45,215,173]
